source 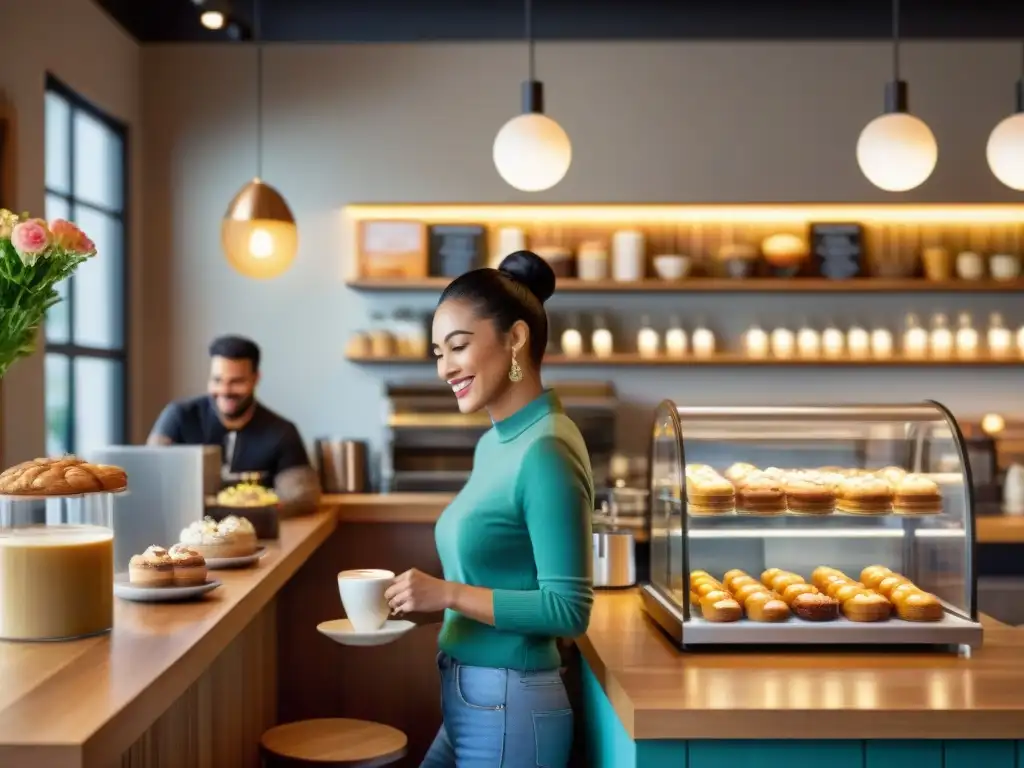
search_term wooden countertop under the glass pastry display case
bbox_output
[578,590,1024,739]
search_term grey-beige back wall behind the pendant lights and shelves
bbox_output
[143,43,1024,456]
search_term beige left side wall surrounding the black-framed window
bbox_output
[0,0,144,465]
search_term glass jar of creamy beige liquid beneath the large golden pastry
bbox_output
[0,492,114,640]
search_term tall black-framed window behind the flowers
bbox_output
[45,77,128,456]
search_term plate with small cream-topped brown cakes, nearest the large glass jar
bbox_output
[114,544,220,603]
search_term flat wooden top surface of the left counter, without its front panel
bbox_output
[0,505,338,768]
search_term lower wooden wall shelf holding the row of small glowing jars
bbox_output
[346,352,1024,368]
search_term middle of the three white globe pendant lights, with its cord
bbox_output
[857,0,939,191]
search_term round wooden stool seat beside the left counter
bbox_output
[260,718,409,768]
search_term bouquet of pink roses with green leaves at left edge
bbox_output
[0,209,96,378]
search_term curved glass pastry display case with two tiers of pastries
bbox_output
[641,400,982,647]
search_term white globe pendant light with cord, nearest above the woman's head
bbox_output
[493,0,572,191]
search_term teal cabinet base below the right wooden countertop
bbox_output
[582,660,1024,768]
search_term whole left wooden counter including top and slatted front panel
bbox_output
[0,507,337,768]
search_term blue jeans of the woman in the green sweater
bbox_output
[420,652,572,768]
